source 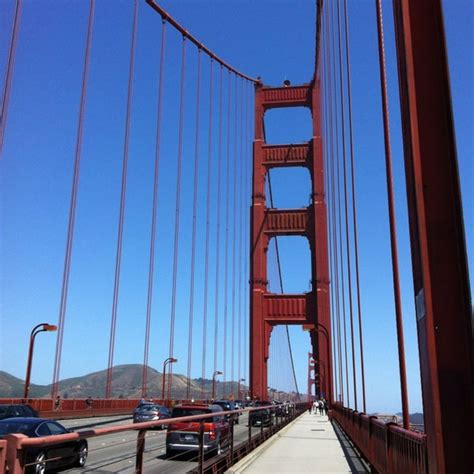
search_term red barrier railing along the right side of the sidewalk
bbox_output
[330,404,428,474]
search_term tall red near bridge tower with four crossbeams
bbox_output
[250,83,332,402]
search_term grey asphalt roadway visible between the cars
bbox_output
[60,414,260,474]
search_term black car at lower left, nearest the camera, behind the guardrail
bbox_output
[0,417,89,474]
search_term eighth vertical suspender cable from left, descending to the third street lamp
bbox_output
[214,66,223,386]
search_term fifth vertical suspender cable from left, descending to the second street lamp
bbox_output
[167,36,186,400]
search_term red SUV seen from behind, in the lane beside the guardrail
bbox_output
[166,404,230,457]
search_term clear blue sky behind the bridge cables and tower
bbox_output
[0,0,474,412]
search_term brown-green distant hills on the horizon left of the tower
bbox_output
[0,364,248,399]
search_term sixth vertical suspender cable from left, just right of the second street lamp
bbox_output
[186,49,201,400]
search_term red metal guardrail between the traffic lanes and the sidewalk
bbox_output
[0,404,306,474]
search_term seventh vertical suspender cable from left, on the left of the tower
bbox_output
[201,58,214,399]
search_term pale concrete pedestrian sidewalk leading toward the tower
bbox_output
[227,412,369,474]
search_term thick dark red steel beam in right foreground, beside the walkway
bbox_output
[394,0,474,473]
